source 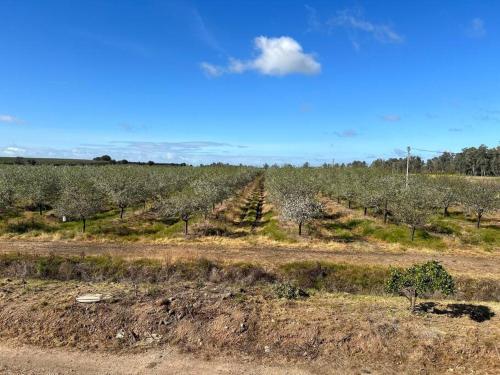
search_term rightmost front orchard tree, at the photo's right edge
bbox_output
[462,181,500,228]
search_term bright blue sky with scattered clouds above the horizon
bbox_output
[0,0,500,164]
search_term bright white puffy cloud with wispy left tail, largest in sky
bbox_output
[200,36,321,77]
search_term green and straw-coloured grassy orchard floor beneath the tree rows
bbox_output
[0,177,500,253]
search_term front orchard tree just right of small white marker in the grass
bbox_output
[56,167,105,232]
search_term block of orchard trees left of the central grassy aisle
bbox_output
[0,166,257,233]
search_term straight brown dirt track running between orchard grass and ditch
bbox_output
[0,240,500,279]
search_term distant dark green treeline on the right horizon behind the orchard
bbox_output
[354,145,500,176]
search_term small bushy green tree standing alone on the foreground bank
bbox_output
[386,260,455,311]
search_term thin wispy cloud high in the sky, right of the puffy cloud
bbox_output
[327,9,404,44]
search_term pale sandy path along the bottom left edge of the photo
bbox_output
[0,344,310,375]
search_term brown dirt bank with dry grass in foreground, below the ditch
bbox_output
[0,280,500,374]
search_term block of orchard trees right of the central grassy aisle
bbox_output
[266,168,500,240]
